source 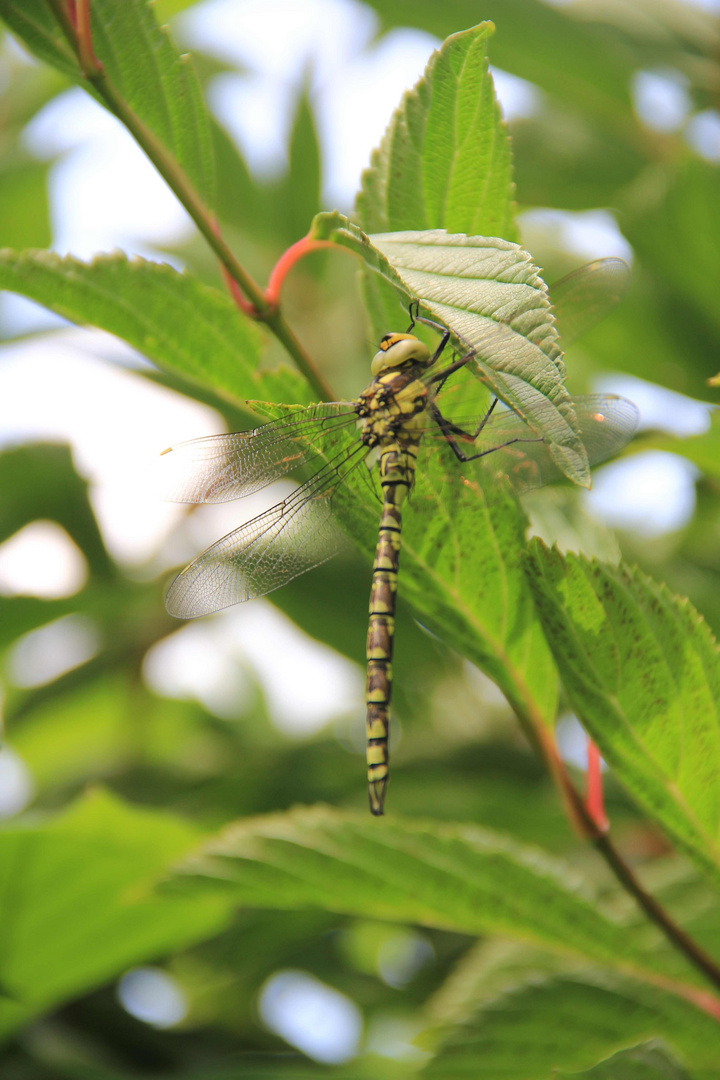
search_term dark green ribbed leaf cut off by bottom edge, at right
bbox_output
[423,977,719,1080]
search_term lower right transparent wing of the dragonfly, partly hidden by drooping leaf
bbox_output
[418,394,639,491]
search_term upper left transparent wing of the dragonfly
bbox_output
[160,402,357,502]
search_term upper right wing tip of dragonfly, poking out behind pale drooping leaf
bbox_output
[549,258,630,348]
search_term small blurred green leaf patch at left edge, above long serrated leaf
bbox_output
[0,161,51,247]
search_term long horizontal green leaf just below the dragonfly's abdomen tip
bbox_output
[179,808,682,984]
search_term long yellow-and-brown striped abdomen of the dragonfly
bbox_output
[366,446,417,815]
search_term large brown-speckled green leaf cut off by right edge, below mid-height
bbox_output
[528,541,720,881]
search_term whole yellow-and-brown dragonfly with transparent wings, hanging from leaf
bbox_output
[163,259,638,815]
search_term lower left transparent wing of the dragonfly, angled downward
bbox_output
[165,442,368,619]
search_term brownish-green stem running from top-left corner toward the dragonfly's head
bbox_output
[50,0,334,401]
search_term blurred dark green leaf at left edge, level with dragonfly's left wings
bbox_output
[0,444,116,579]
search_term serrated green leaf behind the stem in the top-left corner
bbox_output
[0,0,215,206]
